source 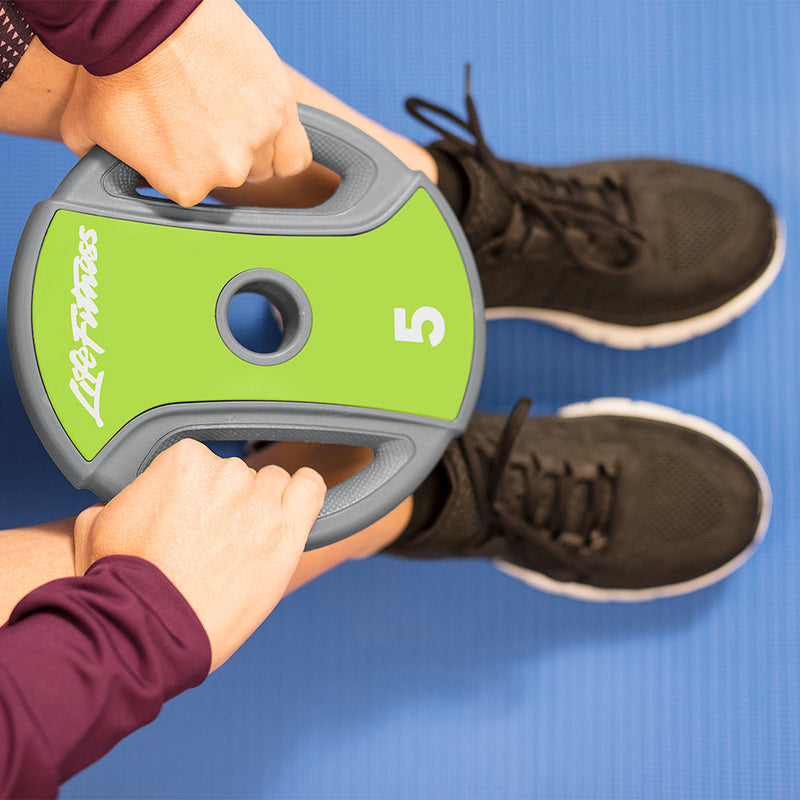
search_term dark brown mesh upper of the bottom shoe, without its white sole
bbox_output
[387,403,763,589]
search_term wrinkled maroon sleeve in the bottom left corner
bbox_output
[0,556,211,798]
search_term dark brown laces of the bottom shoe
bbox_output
[459,397,616,565]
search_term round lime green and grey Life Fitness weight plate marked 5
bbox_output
[8,106,485,549]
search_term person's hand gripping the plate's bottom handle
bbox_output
[75,439,325,670]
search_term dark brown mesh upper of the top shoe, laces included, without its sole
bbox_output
[407,71,778,326]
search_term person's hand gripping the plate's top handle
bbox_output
[61,0,311,206]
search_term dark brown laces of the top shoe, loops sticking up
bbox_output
[406,64,644,273]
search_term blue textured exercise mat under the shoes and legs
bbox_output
[0,0,800,800]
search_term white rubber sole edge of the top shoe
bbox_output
[486,218,786,350]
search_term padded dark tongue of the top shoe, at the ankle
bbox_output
[431,141,513,248]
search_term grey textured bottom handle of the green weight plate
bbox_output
[73,401,460,550]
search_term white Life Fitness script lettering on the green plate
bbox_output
[69,225,105,428]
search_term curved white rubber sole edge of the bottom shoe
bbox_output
[495,397,772,603]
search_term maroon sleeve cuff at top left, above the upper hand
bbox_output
[13,0,201,75]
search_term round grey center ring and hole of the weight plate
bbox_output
[216,269,311,366]
